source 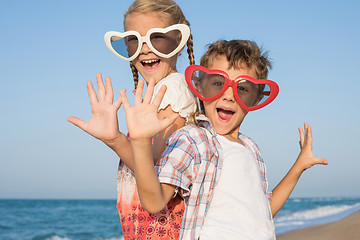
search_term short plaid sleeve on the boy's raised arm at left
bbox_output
[156,131,194,198]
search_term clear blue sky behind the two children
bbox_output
[0,0,360,198]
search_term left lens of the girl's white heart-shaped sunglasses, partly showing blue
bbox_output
[110,35,139,58]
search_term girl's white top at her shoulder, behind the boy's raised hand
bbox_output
[151,73,196,118]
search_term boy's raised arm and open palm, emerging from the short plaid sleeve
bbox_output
[120,80,179,213]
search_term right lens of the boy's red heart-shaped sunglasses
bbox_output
[237,80,270,107]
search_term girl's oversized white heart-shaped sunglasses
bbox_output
[104,24,190,61]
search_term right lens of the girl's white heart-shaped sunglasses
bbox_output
[150,30,182,54]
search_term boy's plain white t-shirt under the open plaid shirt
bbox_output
[200,135,275,240]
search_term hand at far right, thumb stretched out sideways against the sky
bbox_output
[295,123,328,171]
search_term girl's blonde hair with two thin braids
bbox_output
[124,0,195,88]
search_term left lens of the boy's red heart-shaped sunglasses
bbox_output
[192,70,225,101]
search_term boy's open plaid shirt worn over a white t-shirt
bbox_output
[156,115,271,239]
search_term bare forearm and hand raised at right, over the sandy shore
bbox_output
[270,123,328,216]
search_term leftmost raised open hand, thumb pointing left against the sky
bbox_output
[68,73,121,145]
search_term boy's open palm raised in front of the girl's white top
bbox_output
[120,80,179,141]
